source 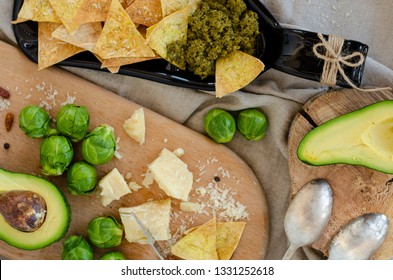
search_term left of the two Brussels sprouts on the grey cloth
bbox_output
[204,108,236,143]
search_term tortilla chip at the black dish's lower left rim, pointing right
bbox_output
[38,22,84,70]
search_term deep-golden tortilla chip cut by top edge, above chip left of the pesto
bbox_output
[126,0,162,26]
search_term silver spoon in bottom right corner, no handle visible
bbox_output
[328,213,389,260]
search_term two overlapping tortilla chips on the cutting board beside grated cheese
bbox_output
[171,218,246,260]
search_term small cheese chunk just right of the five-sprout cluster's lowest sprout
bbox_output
[98,168,131,206]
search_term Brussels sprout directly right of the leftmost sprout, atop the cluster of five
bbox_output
[56,104,90,142]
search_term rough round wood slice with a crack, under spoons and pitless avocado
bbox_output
[288,89,393,259]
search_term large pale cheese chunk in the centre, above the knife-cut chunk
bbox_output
[149,148,193,201]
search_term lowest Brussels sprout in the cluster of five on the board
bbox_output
[67,161,98,195]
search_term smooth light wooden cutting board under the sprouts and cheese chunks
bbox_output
[0,42,269,259]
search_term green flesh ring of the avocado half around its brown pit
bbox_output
[0,169,71,250]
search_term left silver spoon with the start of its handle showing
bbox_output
[282,179,333,260]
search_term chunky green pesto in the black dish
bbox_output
[167,0,259,79]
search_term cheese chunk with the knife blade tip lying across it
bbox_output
[119,198,171,244]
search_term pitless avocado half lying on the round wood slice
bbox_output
[297,100,393,174]
